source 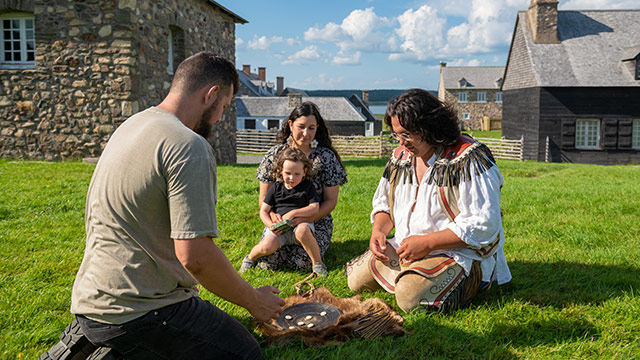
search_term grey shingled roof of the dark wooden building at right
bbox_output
[504,10,640,89]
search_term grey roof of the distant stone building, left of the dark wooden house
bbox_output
[441,66,504,90]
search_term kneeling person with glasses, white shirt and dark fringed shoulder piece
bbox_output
[346,89,511,312]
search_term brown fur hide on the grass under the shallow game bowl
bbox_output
[258,287,406,347]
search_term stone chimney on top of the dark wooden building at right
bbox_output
[527,0,560,44]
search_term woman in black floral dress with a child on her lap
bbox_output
[256,102,347,270]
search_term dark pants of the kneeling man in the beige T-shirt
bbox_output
[77,297,262,360]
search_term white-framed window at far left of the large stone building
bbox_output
[0,13,36,69]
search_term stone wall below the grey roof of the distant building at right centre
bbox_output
[445,88,502,130]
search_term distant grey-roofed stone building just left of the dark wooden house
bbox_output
[438,63,504,130]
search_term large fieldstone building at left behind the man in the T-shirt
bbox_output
[0,0,247,162]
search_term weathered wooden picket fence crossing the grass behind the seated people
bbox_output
[236,129,524,160]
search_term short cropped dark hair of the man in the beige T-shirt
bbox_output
[171,51,238,94]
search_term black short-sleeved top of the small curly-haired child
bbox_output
[264,179,320,216]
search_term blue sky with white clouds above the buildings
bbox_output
[217,0,639,90]
